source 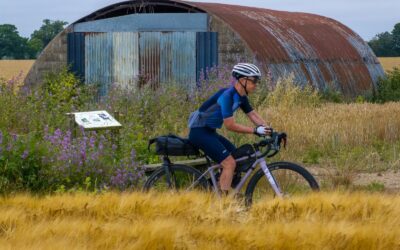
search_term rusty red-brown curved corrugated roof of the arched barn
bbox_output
[186,2,383,95]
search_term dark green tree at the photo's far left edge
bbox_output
[0,24,29,59]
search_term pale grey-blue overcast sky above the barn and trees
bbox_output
[0,0,400,40]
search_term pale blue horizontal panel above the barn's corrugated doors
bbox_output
[74,13,208,32]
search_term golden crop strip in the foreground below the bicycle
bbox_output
[0,192,400,249]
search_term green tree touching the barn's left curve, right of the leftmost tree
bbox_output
[29,19,68,57]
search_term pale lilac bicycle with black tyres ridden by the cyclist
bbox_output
[144,132,319,205]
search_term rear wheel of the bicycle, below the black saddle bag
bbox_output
[143,164,208,192]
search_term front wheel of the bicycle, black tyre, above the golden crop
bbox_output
[245,162,319,205]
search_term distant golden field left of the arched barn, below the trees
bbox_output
[0,60,35,80]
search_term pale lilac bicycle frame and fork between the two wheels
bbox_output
[188,151,283,197]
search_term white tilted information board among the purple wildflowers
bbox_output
[73,110,122,129]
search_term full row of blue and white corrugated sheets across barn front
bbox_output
[68,32,218,92]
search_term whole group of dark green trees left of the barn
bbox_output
[0,19,68,59]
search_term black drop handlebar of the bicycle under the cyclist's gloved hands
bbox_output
[253,128,287,158]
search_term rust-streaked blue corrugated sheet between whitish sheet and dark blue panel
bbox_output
[139,32,196,87]
